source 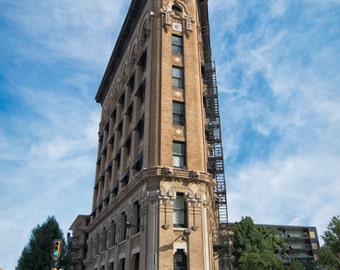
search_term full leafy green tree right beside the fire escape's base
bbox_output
[232,217,286,270]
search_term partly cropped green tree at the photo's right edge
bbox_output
[318,216,340,270]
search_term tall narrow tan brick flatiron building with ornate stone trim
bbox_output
[70,0,227,270]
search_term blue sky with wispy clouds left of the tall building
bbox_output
[0,1,128,270]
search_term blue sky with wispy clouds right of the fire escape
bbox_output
[211,1,340,238]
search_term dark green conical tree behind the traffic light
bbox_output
[15,216,70,270]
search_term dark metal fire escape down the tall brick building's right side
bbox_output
[198,0,232,270]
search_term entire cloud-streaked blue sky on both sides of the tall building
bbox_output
[0,0,340,270]
